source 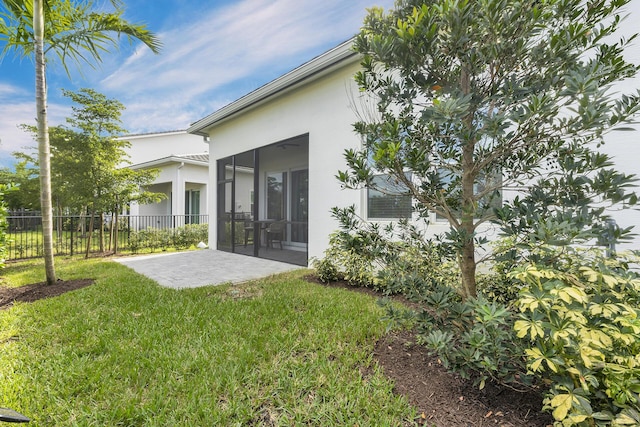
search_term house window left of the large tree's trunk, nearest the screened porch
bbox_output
[367,174,412,219]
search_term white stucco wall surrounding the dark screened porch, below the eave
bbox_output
[200,59,497,258]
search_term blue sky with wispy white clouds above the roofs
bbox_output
[0,0,394,166]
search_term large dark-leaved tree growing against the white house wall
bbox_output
[338,0,640,297]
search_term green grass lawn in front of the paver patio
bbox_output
[0,259,415,426]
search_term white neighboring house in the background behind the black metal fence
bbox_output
[122,131,209,229]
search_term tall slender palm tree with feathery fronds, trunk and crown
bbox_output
[0,0,160,284]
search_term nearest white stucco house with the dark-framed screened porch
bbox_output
[187,41,640,265]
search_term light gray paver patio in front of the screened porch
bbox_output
[114,249,301,289]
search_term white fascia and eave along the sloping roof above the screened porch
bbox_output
[187,39,360,136]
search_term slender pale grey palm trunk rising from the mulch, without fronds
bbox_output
[33,0,56,285]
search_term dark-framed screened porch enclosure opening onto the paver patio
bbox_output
[216,135,309,266]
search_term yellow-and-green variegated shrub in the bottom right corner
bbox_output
[510,247,640,426]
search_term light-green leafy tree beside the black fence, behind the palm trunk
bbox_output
[22,89,162,256]
